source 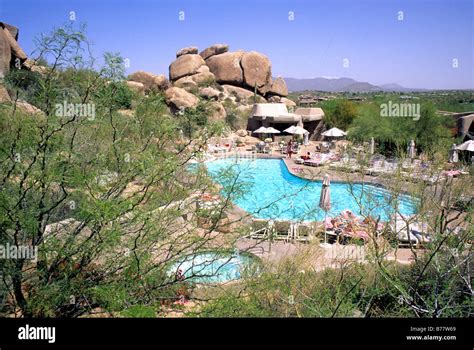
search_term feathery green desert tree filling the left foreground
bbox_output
[0,23,230,317]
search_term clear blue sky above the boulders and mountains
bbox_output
[0,0,474,89]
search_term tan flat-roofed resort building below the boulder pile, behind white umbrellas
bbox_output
[247,103,324,139]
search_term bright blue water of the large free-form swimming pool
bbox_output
[206,159,416,221]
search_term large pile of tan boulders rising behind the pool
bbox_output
[127,44,295,119]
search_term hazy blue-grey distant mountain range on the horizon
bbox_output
[283,78,426,92]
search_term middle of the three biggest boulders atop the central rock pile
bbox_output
[206,51,244,85]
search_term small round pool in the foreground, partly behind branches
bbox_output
[171,252,257,283]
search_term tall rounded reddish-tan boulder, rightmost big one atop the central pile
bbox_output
[240,51,272,94]
